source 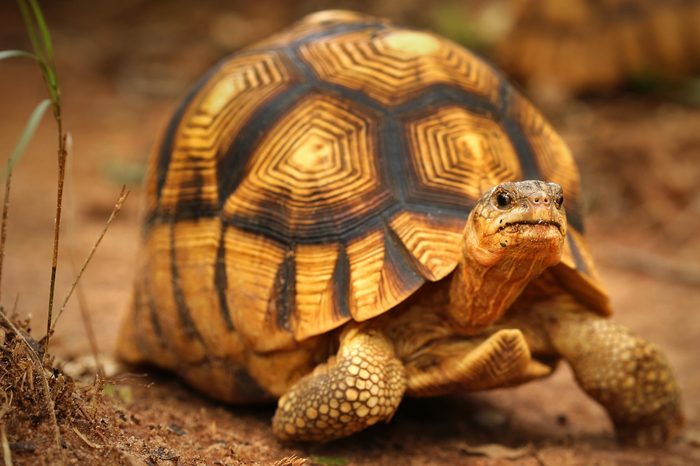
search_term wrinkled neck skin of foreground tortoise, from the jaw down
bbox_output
[447,209,563,335]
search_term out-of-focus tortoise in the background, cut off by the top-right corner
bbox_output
[496,0,700,93]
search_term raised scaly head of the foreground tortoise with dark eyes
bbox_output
[465,181,566,267]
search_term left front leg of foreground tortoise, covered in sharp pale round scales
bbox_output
[272,327,406,441]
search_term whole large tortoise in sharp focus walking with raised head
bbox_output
[118,11,683,444]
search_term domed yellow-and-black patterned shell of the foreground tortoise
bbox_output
[133,12,608,354]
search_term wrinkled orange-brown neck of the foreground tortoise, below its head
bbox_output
[447,242,551,334]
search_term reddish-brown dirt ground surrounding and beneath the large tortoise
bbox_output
[0,0,700,465]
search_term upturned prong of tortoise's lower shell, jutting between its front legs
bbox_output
[405,329,551,396]
